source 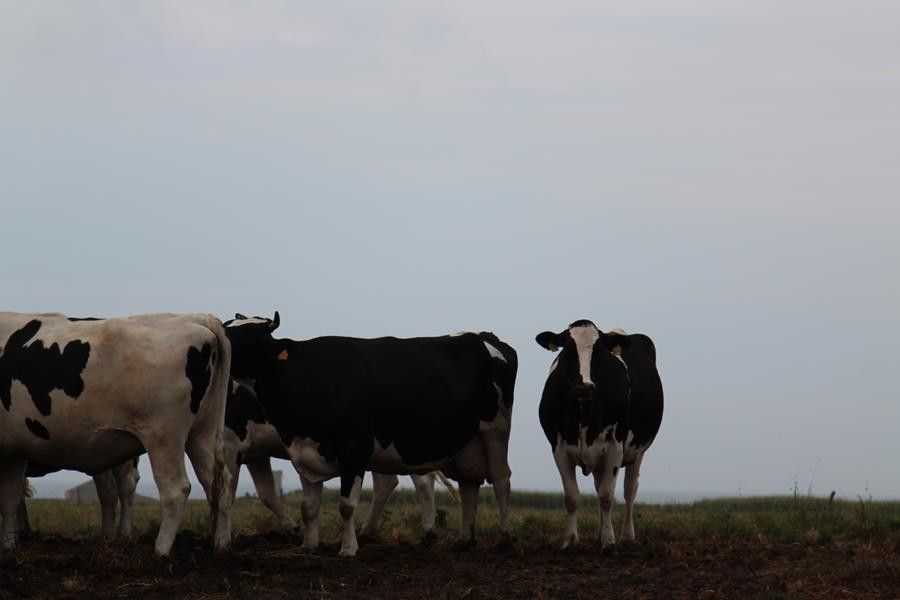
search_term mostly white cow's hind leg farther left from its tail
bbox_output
[144,439,191,556]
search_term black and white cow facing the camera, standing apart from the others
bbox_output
[536,320,663,548]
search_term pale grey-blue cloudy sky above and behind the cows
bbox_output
[0,0,900,498]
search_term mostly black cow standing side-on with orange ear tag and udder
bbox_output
[225,311,517,556]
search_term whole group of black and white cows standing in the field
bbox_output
[0,312,663,556]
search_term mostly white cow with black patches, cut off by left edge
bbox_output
[0,312,233,556]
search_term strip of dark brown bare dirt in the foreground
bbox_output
[0,533,900,600]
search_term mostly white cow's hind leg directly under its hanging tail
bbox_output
[182,426,234,550]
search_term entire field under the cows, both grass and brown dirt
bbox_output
[0,489,900,598]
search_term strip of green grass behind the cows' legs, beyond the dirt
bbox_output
[22,487,900,546]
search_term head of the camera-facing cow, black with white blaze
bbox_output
[535,319,629,403]
